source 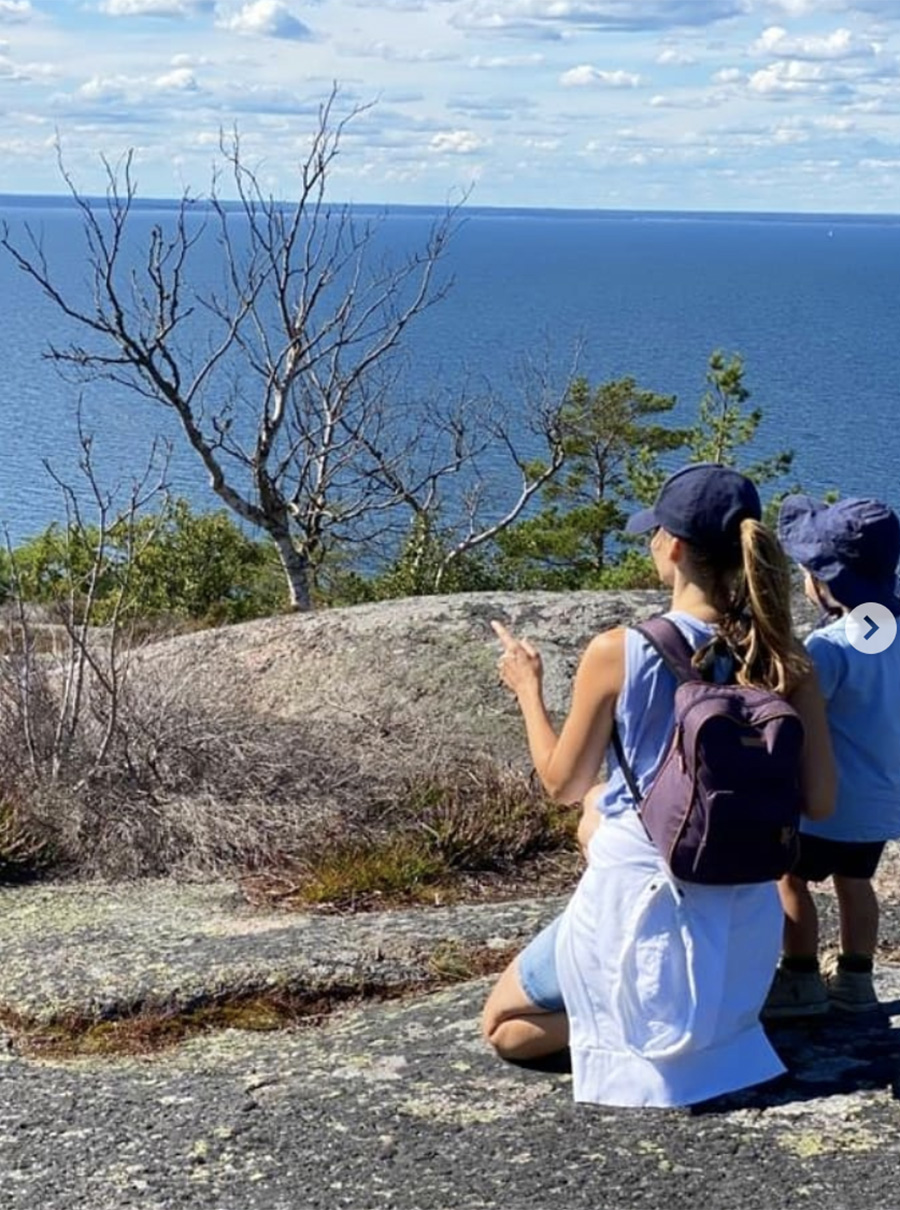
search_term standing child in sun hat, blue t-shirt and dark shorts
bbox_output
[763,496,900,1019]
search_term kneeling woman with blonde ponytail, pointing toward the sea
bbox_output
[483,463,835,1106]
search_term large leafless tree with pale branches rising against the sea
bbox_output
[0,90,563,610]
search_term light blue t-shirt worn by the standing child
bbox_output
[801,617,900,842]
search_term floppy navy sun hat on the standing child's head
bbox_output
[778,496,900,615]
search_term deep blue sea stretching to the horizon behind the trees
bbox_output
[0,197,900,542]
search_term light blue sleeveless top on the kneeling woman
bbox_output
[598,610,715,816]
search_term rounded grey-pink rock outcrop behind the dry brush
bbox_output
[128,590,810,793]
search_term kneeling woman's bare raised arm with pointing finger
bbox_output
[491,622,625,802]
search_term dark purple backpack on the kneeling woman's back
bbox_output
[612,617,803,886]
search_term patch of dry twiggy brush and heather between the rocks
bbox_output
[0,634,572,910]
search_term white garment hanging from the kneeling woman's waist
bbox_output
[556,812,785,1106]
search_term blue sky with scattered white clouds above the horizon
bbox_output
[0,0,900,213]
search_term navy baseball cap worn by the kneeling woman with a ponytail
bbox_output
[625,462,762,553]
